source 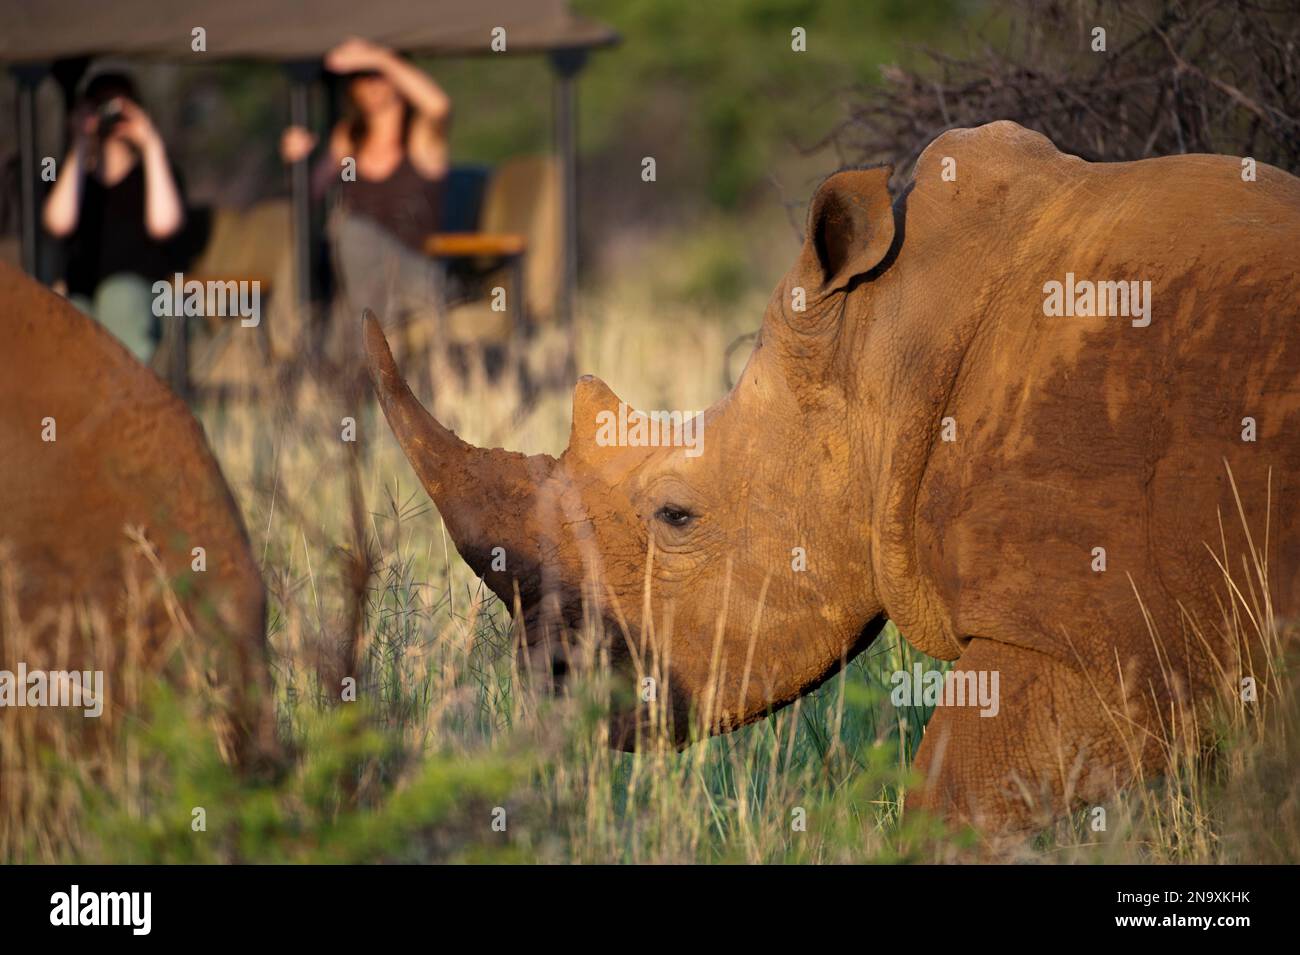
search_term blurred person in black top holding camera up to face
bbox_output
[43,73,185,361]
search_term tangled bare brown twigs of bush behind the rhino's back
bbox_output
[833,0,1300,183]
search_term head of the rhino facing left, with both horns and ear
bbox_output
[364,168,901,747]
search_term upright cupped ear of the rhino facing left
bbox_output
[800,166,894,294]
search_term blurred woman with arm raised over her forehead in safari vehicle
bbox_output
[281,39,451,369]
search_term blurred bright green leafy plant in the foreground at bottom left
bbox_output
[64,687,529,864]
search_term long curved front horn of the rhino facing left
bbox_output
[361,309,555,607]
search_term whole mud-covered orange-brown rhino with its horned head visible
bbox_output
[365,122,1300,828]
